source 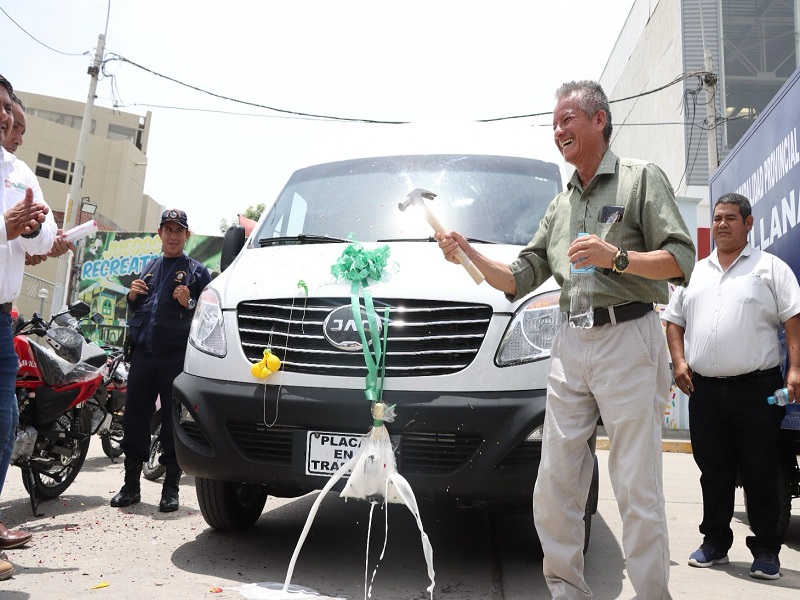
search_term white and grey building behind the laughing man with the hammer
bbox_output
[600,0,800,234]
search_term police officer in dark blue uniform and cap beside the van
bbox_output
[111,208,211,512]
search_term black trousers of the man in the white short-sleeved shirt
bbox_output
[689,368,786,555]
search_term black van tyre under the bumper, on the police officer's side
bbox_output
[195,477,268,531]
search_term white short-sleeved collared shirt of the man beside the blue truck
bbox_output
[662,245,800,377]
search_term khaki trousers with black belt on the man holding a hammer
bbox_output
[533,312,671,600]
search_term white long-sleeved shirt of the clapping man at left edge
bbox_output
[0,148,56,304]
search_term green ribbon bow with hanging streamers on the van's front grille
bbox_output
[331,233,390,402]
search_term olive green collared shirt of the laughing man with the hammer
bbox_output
[508,150,695,310]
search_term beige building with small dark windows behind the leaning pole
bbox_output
[16,91,163,315]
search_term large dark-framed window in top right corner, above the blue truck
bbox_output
[720,0,798,148]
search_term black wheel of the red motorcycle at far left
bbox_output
[22,411,92,500]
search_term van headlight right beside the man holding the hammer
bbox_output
[495,290,561,367]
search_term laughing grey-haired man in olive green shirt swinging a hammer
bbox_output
[437,81,695,600]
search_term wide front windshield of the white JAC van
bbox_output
[254,155,561,245]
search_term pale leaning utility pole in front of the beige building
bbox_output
[51,33,106,312]
